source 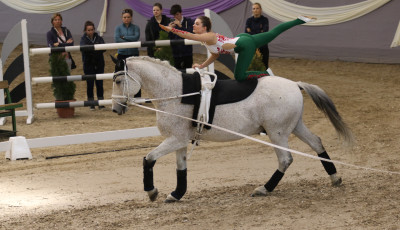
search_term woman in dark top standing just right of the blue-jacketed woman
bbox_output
[145,2,170,57]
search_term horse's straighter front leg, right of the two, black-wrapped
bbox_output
[165,147,187,203]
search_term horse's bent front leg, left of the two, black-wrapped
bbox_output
[143,137,187,201]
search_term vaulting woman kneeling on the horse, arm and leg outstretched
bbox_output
[160,16,315,81]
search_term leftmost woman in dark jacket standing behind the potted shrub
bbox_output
[46,13,76,70]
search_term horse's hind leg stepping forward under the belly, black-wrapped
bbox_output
[251,136,293,197]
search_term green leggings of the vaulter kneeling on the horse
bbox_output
[234,19,305,81]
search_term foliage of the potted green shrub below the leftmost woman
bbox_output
[49,53,76,101]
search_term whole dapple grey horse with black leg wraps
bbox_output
[112,57,353,202]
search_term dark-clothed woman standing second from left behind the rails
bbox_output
[80,21,105,110]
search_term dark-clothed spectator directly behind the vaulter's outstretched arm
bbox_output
[169,4,194,69]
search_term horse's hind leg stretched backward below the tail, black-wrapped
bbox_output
[293,120,342,186]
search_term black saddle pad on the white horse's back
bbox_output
[181,72,258,129]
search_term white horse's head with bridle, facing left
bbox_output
[111,56,141,115]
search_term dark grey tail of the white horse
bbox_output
[297,82,354,145]
